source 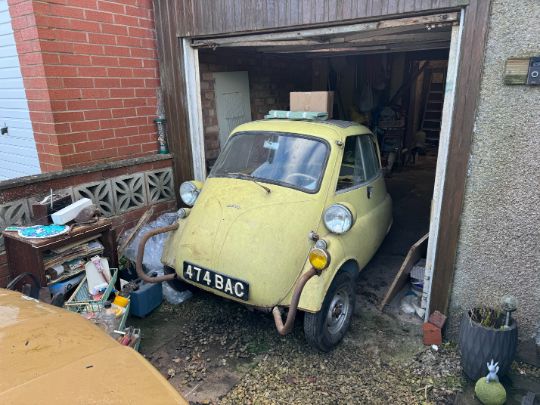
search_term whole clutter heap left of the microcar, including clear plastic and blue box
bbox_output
[3,191,195,349]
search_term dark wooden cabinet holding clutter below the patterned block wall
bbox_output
[2,219,118,287]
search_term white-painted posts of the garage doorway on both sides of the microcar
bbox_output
[181,10,464,312]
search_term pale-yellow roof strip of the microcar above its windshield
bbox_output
[231,118,371,141]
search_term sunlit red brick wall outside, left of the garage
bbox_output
[9,0,159,171]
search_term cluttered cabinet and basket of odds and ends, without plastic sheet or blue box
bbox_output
[3,191,150,349]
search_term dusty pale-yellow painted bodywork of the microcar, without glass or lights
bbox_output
[162,120,391,312]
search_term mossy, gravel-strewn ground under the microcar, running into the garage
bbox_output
[128,156,540,405]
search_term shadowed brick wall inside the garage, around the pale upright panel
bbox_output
[199,49,312,161]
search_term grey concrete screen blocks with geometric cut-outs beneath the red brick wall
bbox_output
[0,167,174,250]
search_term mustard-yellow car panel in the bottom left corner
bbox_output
[0,289,187,405]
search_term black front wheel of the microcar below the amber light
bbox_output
[304,272,355,352]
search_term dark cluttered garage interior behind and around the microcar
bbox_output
[192,16,457,323]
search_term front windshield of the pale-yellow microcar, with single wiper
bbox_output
[209,132,328,193]
